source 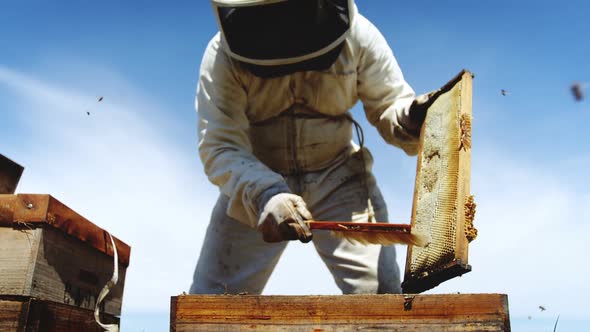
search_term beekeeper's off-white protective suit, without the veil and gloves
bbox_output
[190,8,420,294]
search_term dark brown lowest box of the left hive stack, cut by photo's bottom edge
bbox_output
[0,297,119,332]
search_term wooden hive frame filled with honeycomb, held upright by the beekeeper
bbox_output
[402,71,477,293]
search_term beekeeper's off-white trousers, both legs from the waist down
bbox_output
[190,150,401,294]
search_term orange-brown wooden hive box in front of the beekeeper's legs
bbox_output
[170,294,510,331]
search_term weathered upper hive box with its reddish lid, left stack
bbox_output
[0,194,131,316]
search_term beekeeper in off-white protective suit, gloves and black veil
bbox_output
[190,0,438,294]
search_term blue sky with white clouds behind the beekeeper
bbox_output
[0,0,590,331]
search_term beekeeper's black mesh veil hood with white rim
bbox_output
[211,0,356,66]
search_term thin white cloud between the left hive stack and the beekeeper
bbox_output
[0,67,217,311]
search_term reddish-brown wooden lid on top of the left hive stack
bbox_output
[0,194,131,266]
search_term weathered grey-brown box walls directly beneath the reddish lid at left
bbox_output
[0,227,126,315]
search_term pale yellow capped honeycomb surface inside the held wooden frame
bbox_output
[410,88,461,274]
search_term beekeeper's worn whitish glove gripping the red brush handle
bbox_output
[258,193,312,243]
